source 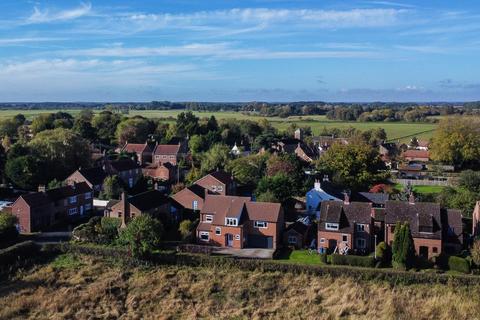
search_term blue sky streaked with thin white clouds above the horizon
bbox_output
[0,0,480,102]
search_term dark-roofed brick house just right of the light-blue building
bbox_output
[318,196,374,253]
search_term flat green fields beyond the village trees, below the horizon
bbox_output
[0,109,436,141]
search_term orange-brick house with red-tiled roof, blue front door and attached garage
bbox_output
[197,194,284,249]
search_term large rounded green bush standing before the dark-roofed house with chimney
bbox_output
[118,215,163,258]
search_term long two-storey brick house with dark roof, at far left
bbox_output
[12,182,93,233]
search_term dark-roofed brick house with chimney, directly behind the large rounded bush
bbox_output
[105,190,171,226]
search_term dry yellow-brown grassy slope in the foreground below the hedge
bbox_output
[0,255,480,319]
